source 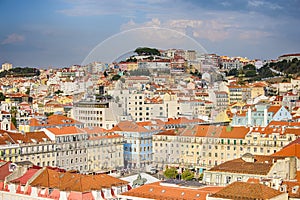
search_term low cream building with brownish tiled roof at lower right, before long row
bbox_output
[203,153,296,188]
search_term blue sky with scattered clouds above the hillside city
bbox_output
[0,0,300,67]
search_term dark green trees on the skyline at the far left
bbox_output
[0,67,40,78]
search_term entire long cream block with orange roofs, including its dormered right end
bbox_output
[153,124,300,173]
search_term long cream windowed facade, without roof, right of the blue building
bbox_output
[153,126,297,173]
